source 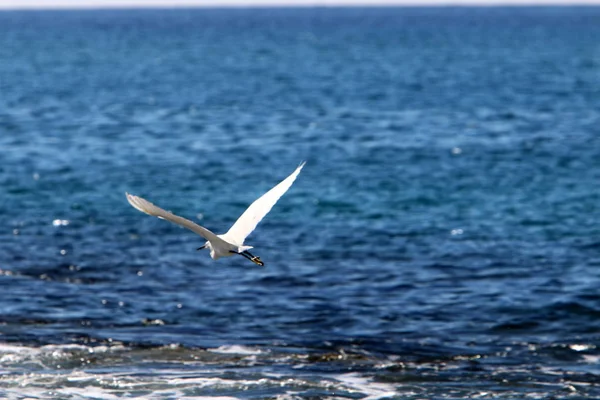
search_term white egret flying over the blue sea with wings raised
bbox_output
[125,162,305,266]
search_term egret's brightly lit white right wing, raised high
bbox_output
[223,162,305,246]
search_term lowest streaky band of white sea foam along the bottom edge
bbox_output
[0,368,396,400]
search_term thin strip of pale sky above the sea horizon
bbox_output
[0,0,600,9]
